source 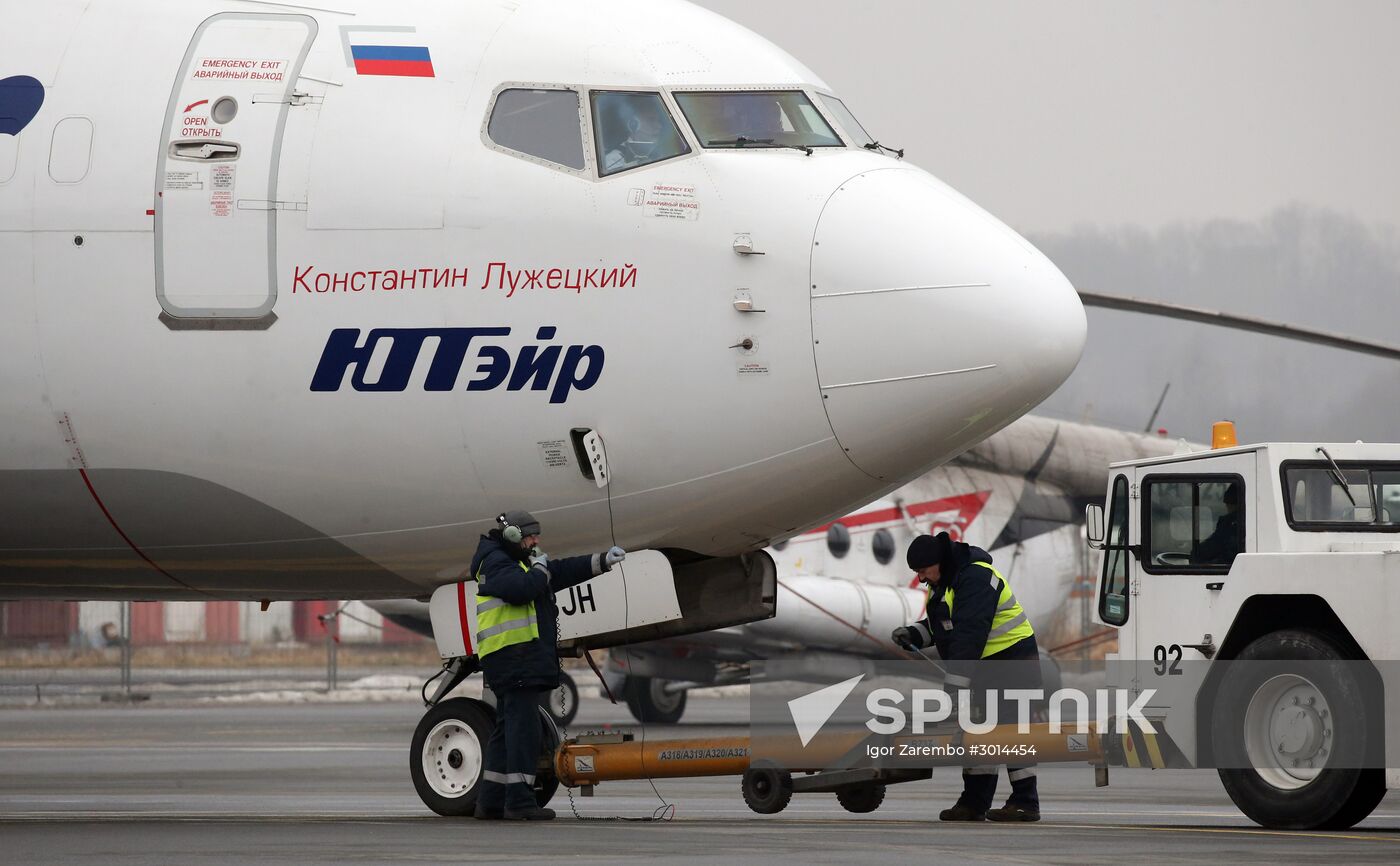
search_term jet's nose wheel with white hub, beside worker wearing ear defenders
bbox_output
[409,698,496,817]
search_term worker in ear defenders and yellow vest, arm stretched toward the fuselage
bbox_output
[470,511,627,821]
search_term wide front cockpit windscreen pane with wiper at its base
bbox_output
[675,91,841,148]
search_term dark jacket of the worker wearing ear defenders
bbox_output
[472,529,606,694]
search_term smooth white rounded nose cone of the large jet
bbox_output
[812,168,1086,483]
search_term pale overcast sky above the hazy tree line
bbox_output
[699,0,1400,232]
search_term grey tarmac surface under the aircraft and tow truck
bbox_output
[0,697,1400,866]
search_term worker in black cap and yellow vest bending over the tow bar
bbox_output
[890,532,1040,821]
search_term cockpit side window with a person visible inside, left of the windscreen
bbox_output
[592,91,690,176]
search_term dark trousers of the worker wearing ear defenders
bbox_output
[476,688,542,811]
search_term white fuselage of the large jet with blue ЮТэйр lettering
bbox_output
[0,0,1085,599]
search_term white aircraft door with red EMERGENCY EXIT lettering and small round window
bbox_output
[155,13,316,319]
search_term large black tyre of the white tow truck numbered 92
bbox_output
[1211,630,1386,830]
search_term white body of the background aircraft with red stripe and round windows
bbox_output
[705,416,1176,658]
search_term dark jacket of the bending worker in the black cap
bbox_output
[924,541,1039,662]
